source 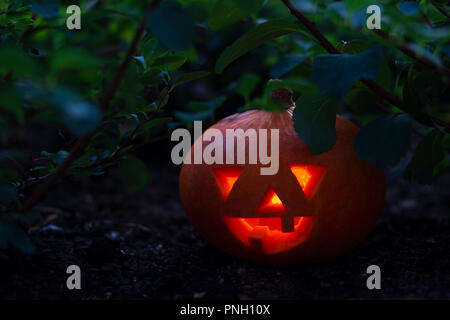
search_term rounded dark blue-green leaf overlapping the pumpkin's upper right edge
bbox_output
[355,114,412,168]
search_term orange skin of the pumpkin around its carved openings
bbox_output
[179,108,386,264]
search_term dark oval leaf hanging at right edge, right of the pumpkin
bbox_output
[409,129,445,184]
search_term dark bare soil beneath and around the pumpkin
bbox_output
[0,145,450,299]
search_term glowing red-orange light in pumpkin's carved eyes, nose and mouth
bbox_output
[213,165,325,254]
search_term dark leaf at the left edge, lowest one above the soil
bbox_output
[0,219,36,254]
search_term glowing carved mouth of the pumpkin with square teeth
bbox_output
[224,217,315,254]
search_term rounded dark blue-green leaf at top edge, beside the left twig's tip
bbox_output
[147,2,194,50]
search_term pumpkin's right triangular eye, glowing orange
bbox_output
[289,164,326,199]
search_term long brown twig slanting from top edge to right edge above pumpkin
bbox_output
[282,0,450,132]
